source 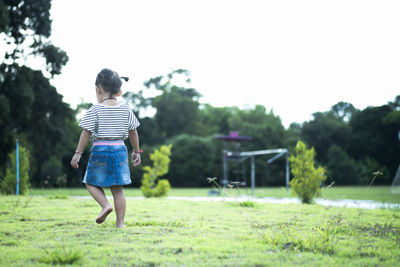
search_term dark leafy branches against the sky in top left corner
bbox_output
[0,0,68,76]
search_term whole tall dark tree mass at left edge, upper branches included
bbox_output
[0,0,70,182]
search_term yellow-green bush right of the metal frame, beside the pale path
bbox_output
[289,141,326,203]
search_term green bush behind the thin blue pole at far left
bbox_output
[0,146,30,194]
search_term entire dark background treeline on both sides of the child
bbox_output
[0,0,400,187]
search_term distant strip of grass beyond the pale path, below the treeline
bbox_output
[30,186,400,203]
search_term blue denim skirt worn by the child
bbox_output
[82,145,132,187]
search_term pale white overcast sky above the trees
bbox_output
[50,0,400,127]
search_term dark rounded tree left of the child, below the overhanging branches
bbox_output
[0,66,79,186]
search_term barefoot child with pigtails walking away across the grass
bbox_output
[71,69,141,228]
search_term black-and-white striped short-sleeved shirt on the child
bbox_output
[79,104,140,141]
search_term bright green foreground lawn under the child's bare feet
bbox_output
[0,194,400,266]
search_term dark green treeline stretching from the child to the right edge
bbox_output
[124,70,400,186]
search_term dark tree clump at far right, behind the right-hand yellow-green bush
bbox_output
[300,99,400,185]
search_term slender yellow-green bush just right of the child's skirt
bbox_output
[140,145,172,197]
